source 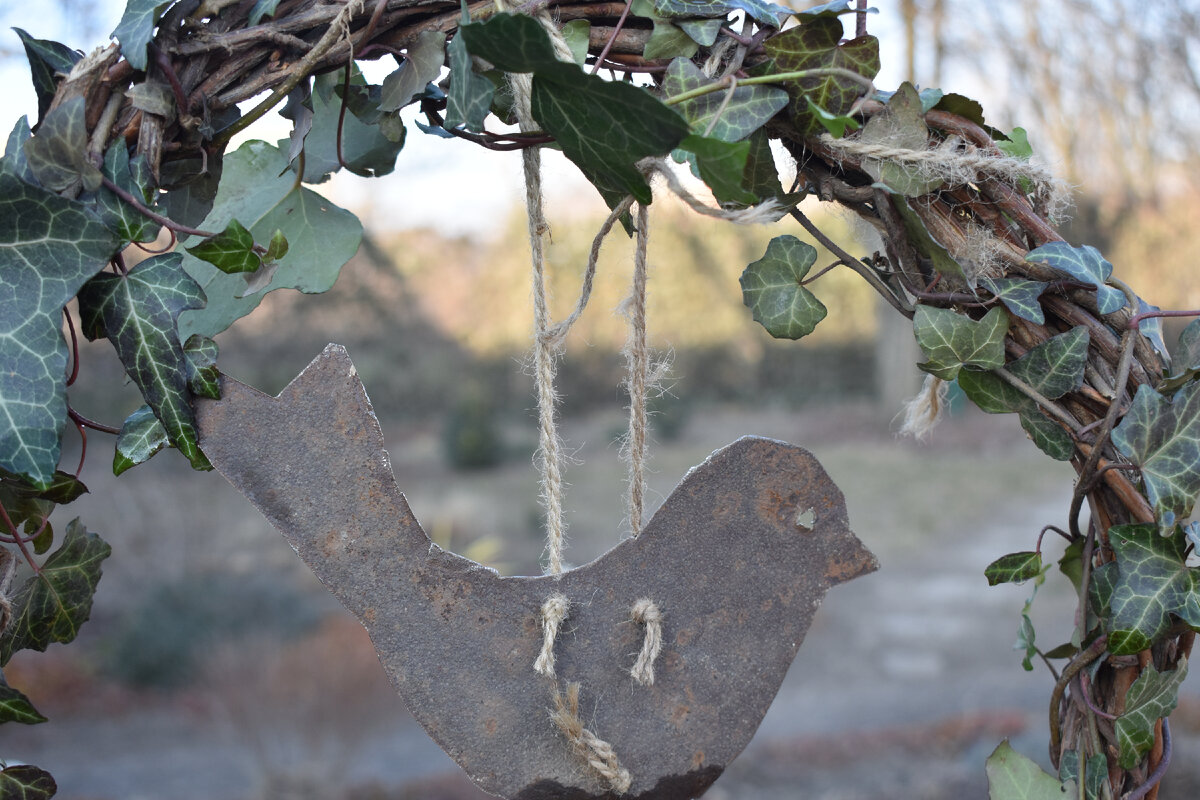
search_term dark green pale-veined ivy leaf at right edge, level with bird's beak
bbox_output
[1109,523,1200,655]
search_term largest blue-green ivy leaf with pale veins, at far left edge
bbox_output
[0,169,116,487]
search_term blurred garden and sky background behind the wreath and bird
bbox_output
[0,0,1200,800]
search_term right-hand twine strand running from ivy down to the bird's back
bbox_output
[622,204,650,536]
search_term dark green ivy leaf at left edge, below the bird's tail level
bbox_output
[0,519,113,667]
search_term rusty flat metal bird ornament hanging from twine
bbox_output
[198,345,877,800]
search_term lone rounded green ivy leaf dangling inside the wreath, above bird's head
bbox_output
[738,235,828,339]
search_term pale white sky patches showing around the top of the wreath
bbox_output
[0,0,904,236]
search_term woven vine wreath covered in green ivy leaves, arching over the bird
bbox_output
[0,0,1200,799]
